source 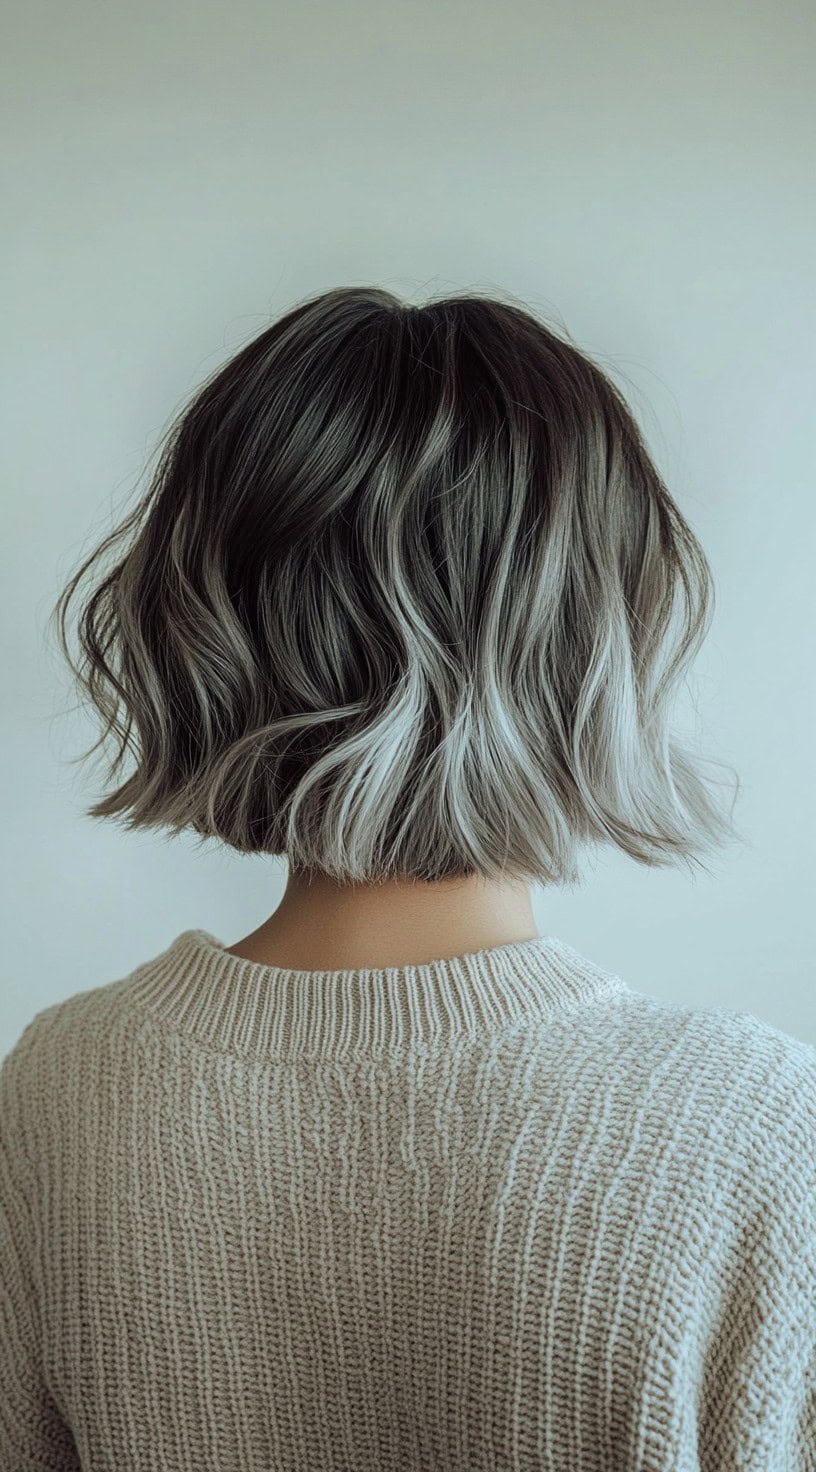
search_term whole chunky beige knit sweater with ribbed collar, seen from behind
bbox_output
[0,930,816,1472]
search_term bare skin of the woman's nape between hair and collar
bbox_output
[227,871,539,972]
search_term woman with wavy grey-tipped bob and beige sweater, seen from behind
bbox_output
[0,289,816,1472]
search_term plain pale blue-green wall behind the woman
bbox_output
[0,0,816,1052]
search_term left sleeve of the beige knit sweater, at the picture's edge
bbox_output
[0,1029,81,1472]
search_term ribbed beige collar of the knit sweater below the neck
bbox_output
[127,930,629,1058]
